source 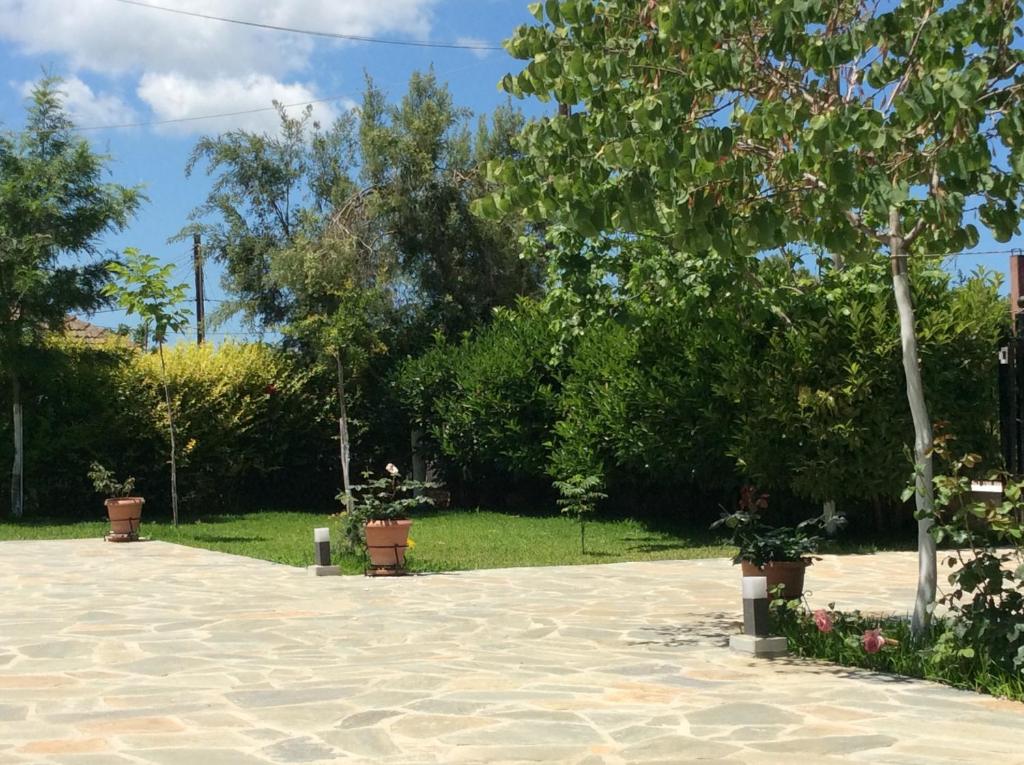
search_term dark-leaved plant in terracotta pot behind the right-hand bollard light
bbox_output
[712,486,843,600]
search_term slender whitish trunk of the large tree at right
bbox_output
[889,210,937,634]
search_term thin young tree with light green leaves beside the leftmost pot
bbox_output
[103,248,190,526]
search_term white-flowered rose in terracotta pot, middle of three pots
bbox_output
[338,463,433,573]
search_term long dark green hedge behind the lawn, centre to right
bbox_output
[401,258,1008,519]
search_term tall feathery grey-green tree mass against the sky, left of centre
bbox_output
[185,74,541,340]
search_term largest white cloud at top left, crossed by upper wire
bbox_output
[0,0,437,77]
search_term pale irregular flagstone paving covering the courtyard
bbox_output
[0,540,1024,765]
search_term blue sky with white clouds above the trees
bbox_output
[0,0,1024,342]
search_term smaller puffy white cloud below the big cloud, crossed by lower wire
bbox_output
[137,73,344,134]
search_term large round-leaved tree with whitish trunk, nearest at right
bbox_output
[489,0,1024,631]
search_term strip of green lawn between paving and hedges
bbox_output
[0,510,735,573]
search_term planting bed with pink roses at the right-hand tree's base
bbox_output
[773,446,1024,700]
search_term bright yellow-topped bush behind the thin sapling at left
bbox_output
[123,342,337,512]
